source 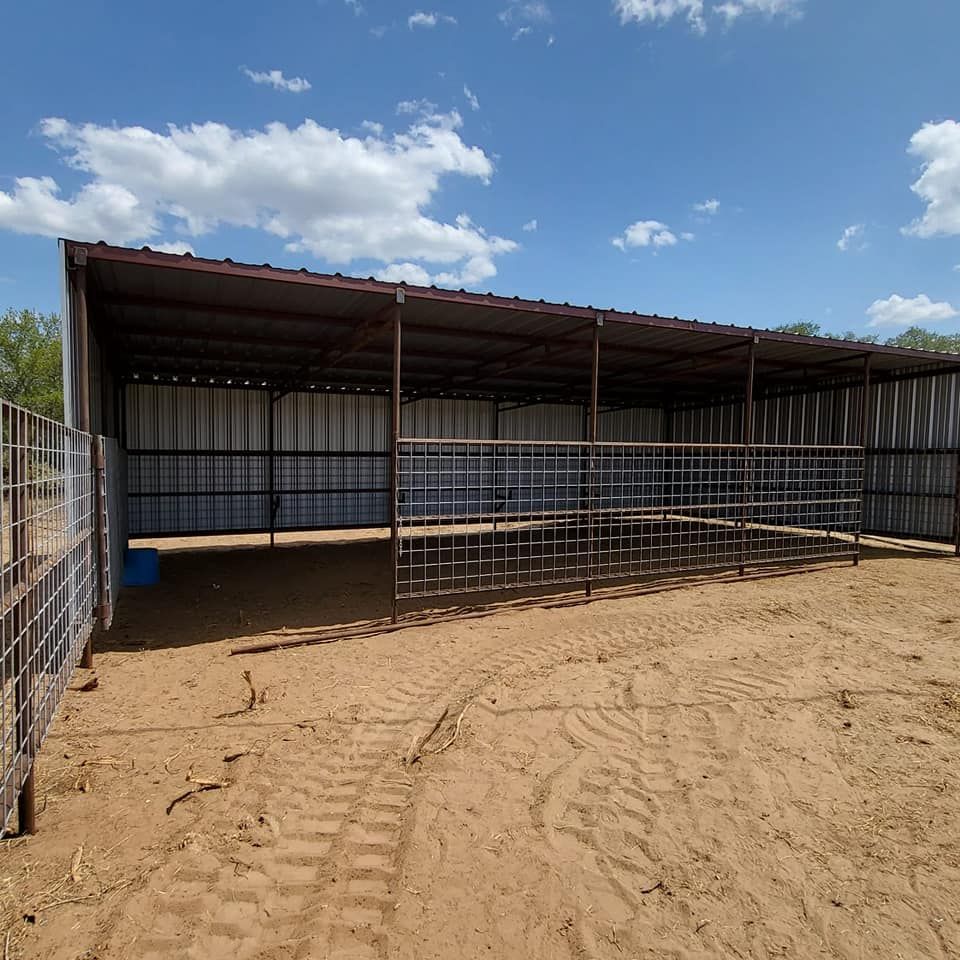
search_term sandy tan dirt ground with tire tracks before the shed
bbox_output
[0,535,960,960]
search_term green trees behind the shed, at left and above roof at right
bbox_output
[0,309,960,420]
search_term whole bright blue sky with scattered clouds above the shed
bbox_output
[0,0,960,335]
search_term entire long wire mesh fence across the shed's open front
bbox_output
[395,440,863,599]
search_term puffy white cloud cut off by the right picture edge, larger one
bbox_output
[903,120,960,237]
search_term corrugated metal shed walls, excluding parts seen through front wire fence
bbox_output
[126,375,960,539]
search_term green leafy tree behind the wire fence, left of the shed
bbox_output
[0,309,63,420]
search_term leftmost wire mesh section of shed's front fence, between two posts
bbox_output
[397,440,590,597]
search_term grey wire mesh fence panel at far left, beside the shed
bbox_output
[0,400,96,828]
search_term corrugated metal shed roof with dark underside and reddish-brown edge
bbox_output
[65,241,960,406]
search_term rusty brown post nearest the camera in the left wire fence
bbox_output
[8,407,37,834]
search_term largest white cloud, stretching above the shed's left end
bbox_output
[0,112,516,283]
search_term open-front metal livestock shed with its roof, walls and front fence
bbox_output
[61,241,960,632]
